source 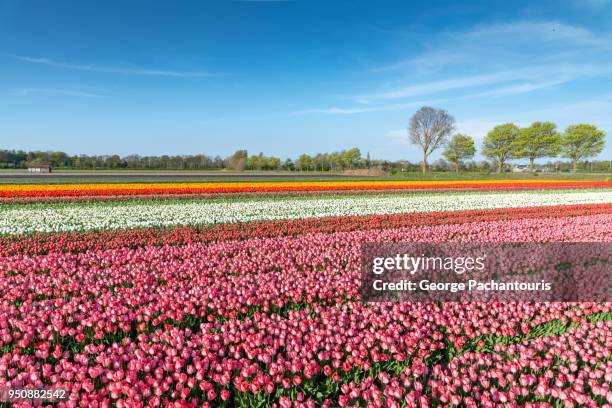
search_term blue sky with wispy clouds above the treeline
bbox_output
[0,0,612,161]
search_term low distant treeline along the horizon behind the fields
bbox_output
[0,148,612,173]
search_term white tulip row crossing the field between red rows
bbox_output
[0,190,612,234]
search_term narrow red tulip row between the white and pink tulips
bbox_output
[0,204,612,256]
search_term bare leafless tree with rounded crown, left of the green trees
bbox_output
[408,106,455,173]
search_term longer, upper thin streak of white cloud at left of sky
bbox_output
[15,56,227,78]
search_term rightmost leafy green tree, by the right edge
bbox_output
[561,123,606,171]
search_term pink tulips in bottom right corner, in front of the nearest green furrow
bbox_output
[308,322,612,408]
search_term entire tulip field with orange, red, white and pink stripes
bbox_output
[0,180,612,407]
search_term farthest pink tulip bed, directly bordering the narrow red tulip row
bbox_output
[0,215,612,337]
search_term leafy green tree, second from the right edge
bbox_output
[514,122,561,172]
